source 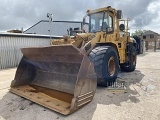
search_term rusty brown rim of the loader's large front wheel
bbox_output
[107,57,116,76]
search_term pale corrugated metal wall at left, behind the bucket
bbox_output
[0,34,59,69]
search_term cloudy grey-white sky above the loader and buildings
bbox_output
[0,0,160,33]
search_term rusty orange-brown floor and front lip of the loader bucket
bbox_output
[10,85,73,115]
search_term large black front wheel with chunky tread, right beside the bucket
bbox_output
[89,46,119,87]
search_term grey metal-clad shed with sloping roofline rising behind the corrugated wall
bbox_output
[24,20,82,36]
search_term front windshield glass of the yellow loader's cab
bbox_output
[89,12,108,32]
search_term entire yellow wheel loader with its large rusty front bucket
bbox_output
[10,6,136,115]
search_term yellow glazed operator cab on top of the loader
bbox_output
[83,6,122,33]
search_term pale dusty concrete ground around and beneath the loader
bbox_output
[0,51,160,120]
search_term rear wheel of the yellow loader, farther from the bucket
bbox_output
[120,45,137,72]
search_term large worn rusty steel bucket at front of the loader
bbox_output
[10,45,97,115]
